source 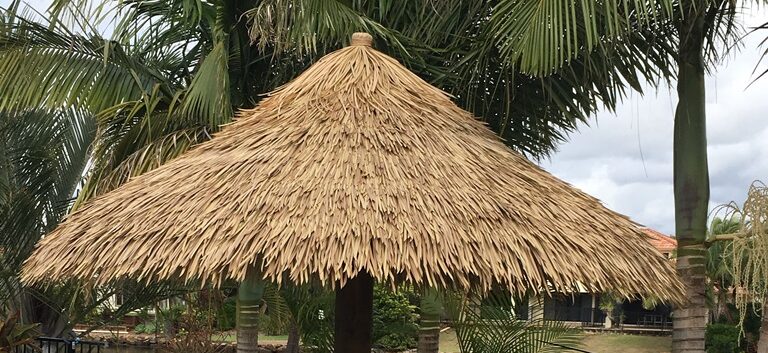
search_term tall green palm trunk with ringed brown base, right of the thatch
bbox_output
[672,0,709,353]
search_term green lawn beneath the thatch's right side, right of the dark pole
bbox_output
[440,330,672,353]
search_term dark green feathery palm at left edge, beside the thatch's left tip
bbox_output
[0,110,94,335]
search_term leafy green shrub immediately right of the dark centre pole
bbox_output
[373,284,418,351]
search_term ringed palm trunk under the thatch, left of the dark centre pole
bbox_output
[237,271,264,353]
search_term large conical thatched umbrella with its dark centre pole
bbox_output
[23,33,681,352]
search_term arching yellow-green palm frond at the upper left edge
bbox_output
[0,13,172,113]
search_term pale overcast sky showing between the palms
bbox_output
[7,0,768,234]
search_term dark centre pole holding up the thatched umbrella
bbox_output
[334,271,373,353]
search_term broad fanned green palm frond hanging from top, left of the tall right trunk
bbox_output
[489,0,675,76]
